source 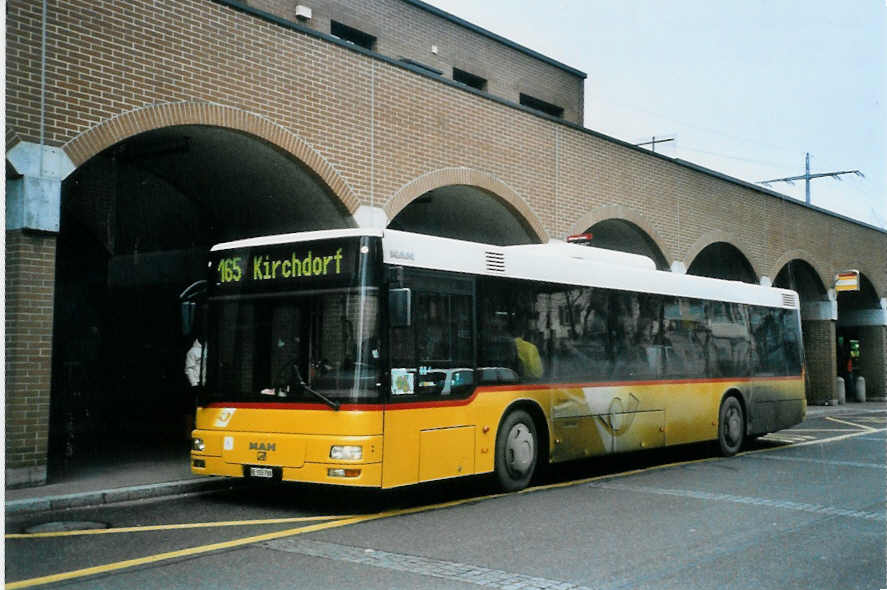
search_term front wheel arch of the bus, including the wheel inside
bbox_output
[494,400,549,492]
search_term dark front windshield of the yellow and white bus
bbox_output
[205,236,382,408]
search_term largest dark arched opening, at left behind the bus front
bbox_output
[50,125,350,478]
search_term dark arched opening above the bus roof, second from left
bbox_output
[388,184,539,246]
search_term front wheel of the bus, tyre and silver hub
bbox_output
[496,410,539,492]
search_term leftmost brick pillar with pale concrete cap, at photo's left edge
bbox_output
[5,142,74,487]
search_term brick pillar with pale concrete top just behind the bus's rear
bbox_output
[801,301,838,405]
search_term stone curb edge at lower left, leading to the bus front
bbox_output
[6,477,234,516]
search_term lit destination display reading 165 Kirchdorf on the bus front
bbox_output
[210,238,374,291]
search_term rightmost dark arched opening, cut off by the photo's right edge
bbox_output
[836,273,887,399]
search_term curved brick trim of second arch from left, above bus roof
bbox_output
[382,167,549,243]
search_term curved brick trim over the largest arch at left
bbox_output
[62,102,360,214]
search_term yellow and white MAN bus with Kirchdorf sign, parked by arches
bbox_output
[191,229,806,490]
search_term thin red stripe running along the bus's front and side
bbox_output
[206,375,803,412]
